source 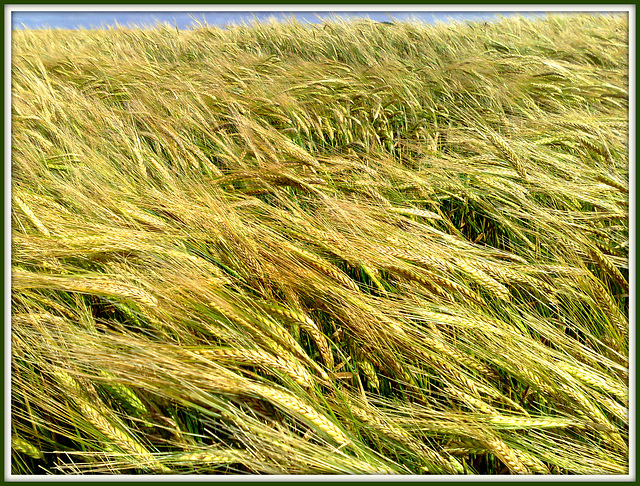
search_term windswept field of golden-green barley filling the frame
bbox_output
[7,15,633,475]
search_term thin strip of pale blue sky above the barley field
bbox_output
[11,10,560,29]
